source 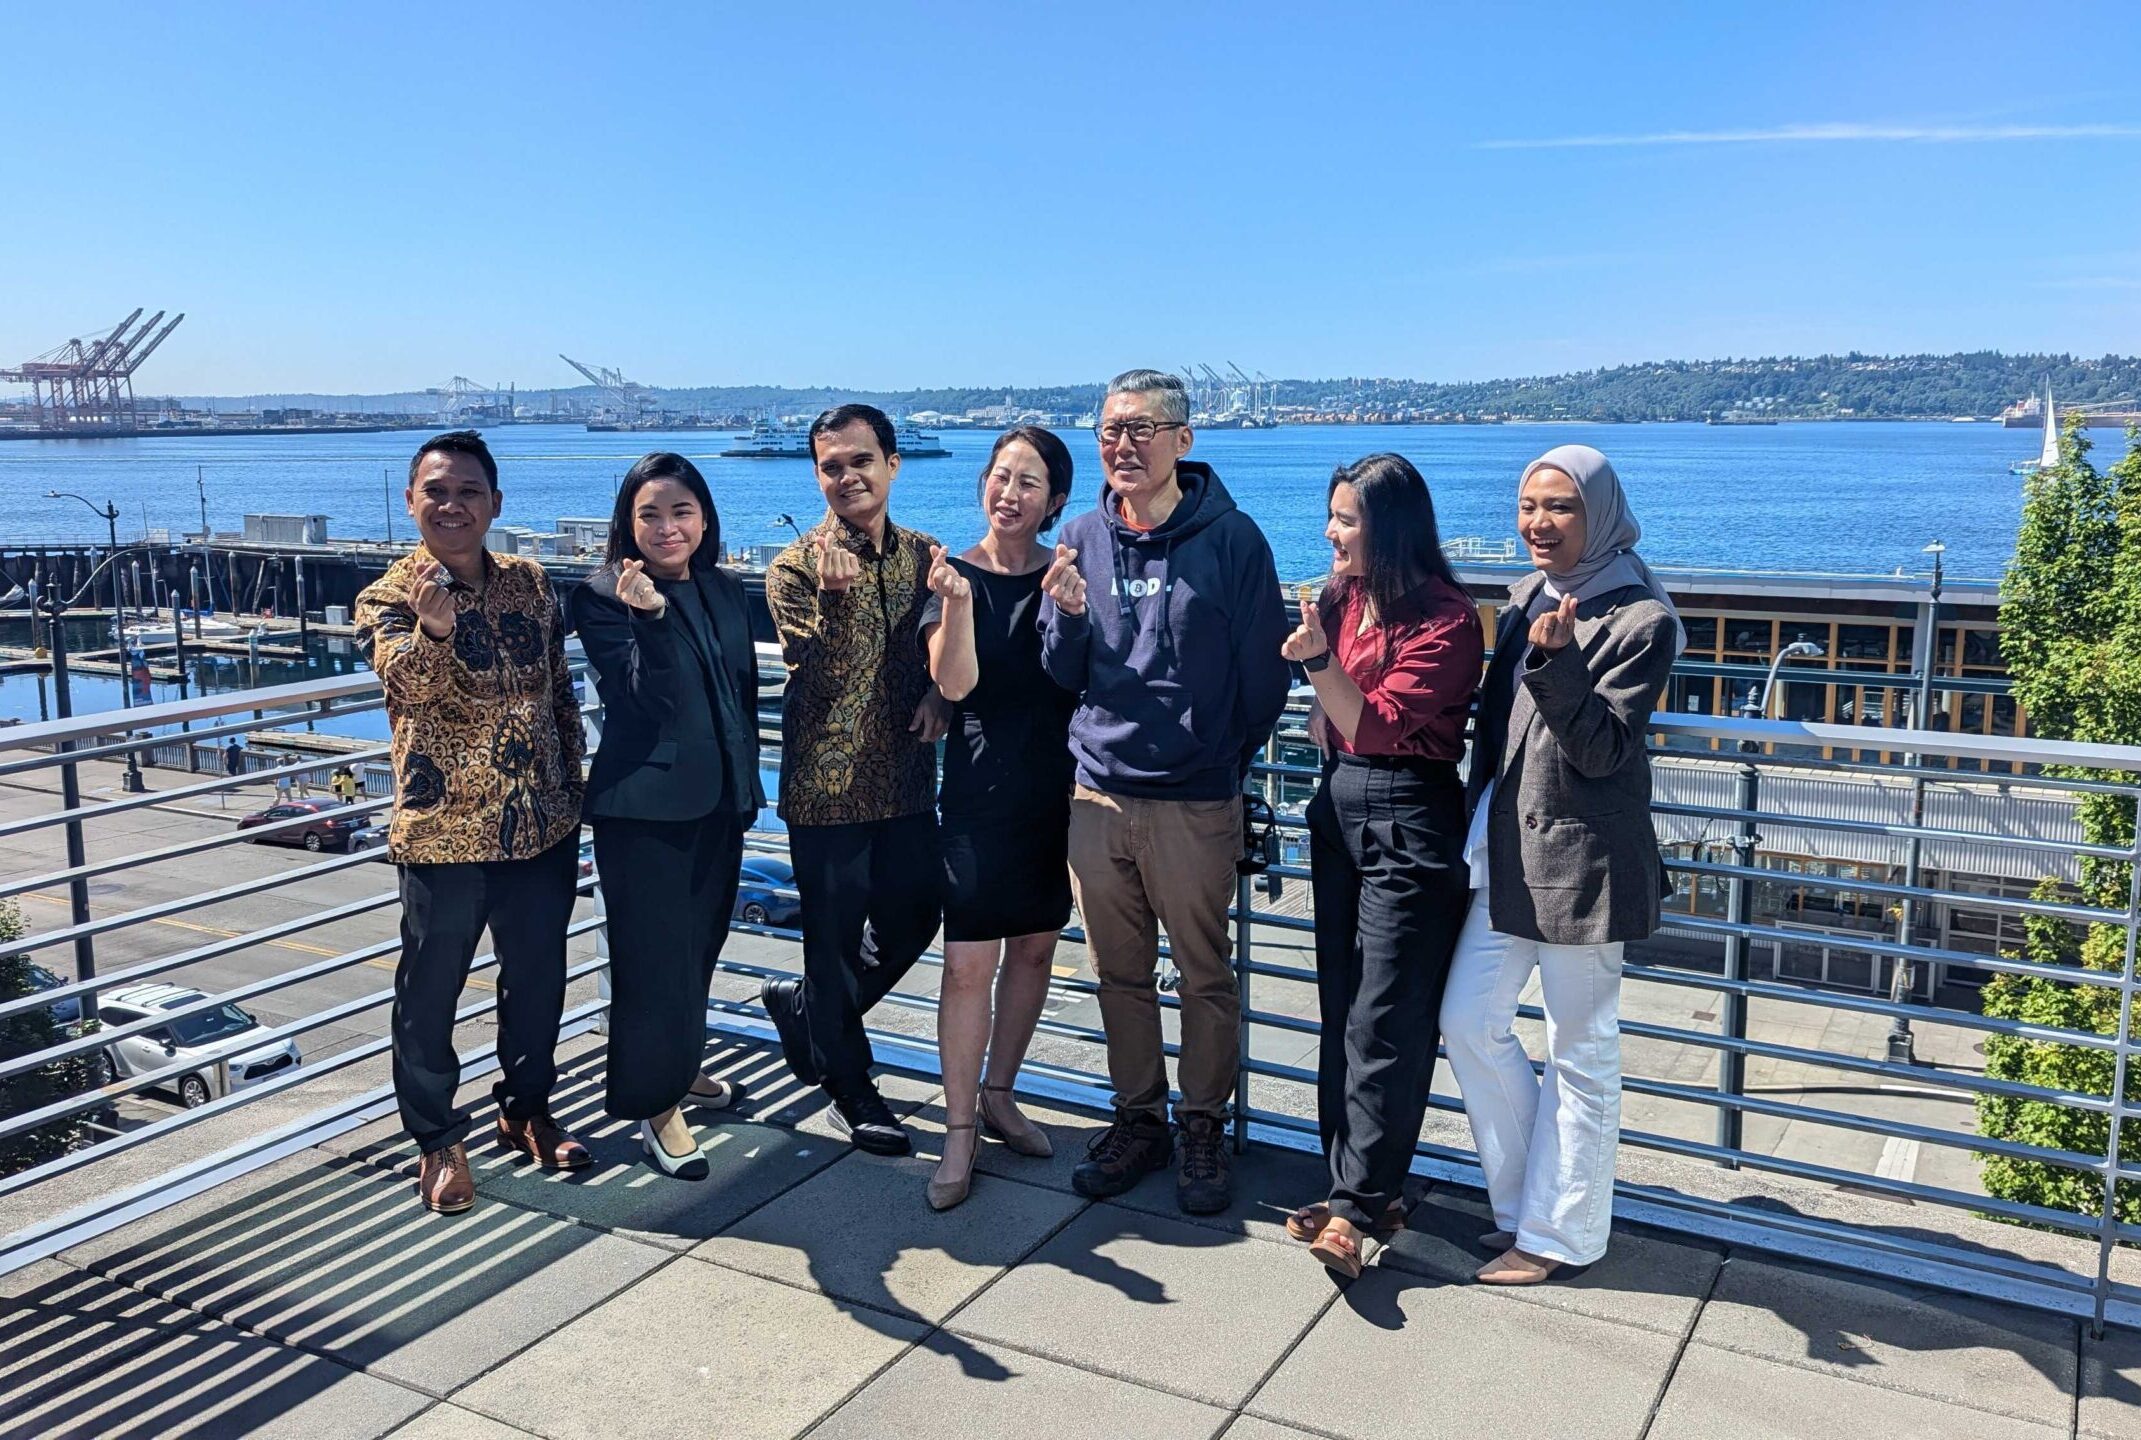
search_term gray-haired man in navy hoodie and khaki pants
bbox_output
[1041,370,1287,1215]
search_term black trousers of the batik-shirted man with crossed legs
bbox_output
[788,811,944,1085]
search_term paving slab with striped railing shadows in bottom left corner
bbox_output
[0,1260,430,1440]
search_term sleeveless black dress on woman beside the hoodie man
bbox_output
[923,558,1077,939]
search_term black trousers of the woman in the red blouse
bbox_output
[1308,755,1469,1230]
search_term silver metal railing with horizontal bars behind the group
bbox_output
[0,674,2141,1322]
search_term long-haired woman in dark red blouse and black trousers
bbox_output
[1282,456,1486,1277]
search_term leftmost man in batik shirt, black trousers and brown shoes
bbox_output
[358,430,591,1213]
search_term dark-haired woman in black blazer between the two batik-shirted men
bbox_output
[572,451,766,1179]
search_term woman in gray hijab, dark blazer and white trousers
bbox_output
[1441,445,1685,1284]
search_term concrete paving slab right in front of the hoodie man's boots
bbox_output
[946,1205,1332,1408]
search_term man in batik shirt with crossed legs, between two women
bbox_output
[762,404,944,1155]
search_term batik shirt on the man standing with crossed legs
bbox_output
[766,511,936,826]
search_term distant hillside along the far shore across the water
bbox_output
[158,351,2141,422]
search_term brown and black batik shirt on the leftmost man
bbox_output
[358,546,587,864]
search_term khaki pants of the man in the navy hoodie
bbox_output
[1071,785,1242,1117]
